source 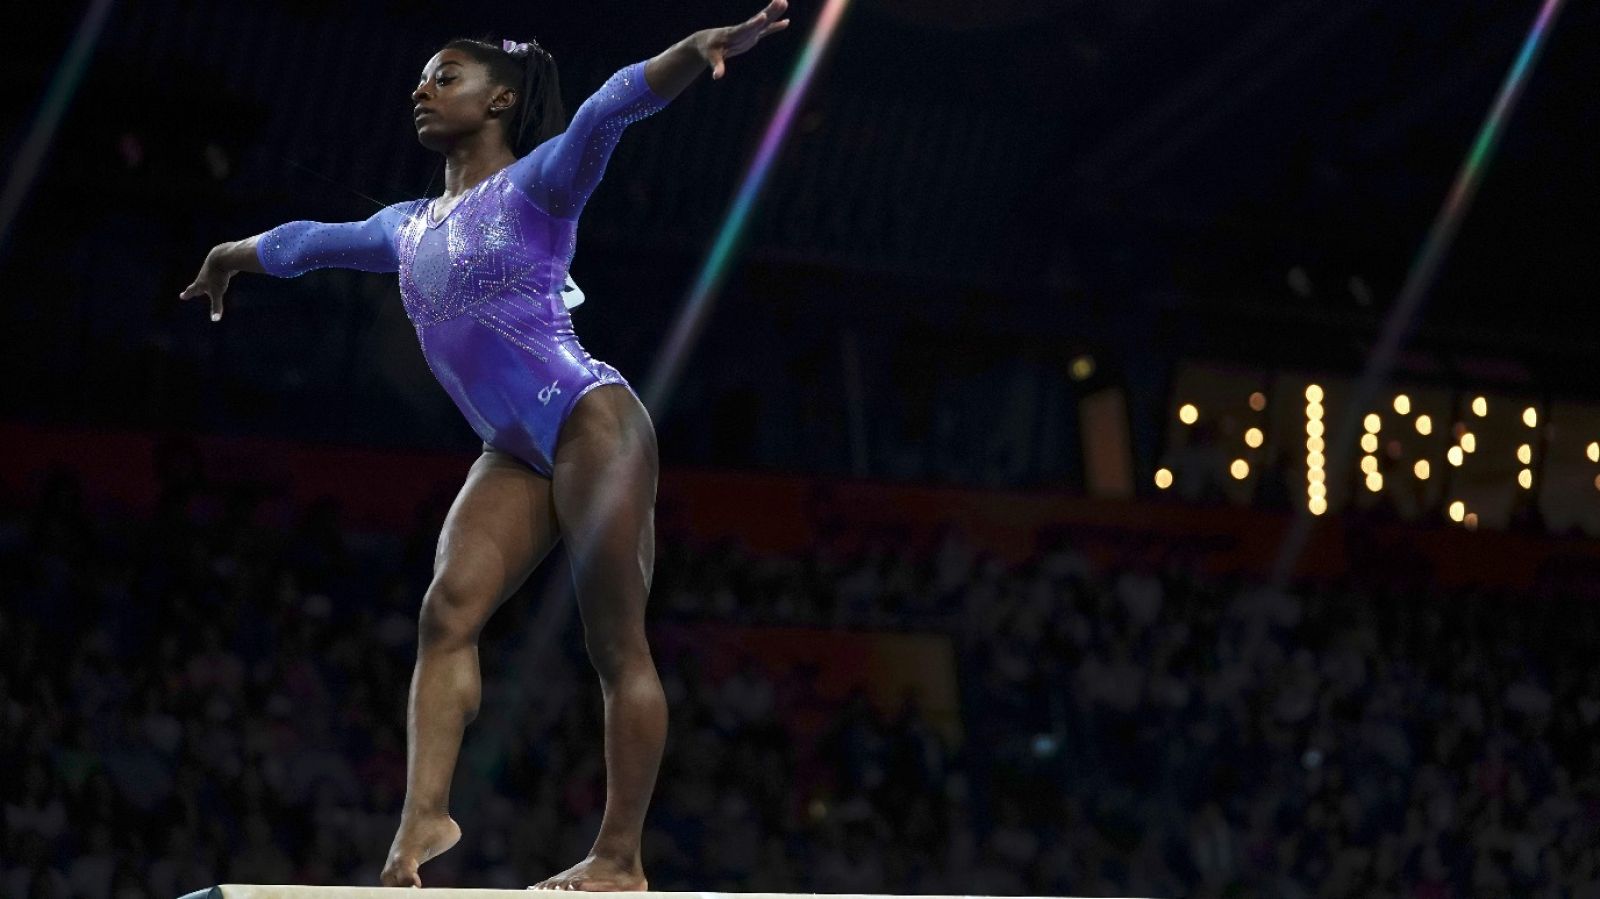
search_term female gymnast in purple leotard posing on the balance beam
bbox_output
[179,0,789,889]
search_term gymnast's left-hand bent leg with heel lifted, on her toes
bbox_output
[381,450,558,886]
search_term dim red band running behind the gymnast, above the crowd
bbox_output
[0,424,1600,590]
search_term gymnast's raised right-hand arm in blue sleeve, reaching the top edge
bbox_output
[510,0,789,219]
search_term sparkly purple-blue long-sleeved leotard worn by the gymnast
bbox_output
[258,62,667,477]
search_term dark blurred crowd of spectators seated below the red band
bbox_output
[0,451,1600,899]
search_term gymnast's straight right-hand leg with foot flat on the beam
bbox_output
[539,384,667,889]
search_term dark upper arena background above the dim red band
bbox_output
[0,0,1600,486]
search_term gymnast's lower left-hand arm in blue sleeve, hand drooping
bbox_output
[178,203,406,322]
